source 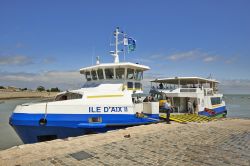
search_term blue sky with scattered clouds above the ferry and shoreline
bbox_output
[0,0,250,93]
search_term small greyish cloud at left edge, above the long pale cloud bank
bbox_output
[0,55,32,65]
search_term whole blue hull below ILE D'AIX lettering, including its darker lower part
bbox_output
[10,113,159,143]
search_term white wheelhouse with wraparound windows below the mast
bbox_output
[80,62,150,91]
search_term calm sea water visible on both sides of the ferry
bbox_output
[0,95,250,150]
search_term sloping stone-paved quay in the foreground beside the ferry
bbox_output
[0,119,250,166]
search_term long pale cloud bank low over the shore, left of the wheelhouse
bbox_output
[0,71,85,89]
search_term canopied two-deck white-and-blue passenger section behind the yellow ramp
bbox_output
[150,77,227,117]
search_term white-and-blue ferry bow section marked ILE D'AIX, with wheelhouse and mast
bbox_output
[9,28,159,143]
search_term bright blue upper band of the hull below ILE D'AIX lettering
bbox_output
[10,113,159,128]
